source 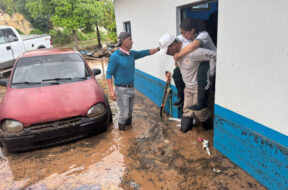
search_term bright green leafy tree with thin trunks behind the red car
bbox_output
[25,0,116,48]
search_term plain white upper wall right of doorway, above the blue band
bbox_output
[215,0,288,135]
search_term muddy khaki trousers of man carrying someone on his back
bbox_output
[183,86,210,122]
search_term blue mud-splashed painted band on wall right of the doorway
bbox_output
[214,105,288,190]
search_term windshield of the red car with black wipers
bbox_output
[12,54,90,85]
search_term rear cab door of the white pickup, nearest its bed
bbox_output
[2,28,25,65]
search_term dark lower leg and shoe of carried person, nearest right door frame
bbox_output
[188,86,209,111]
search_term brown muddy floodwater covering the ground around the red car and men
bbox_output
[0,58,265,190]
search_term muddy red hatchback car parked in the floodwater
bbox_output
[0,48,112,152]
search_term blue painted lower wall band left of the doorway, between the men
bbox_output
[134,69,181,118]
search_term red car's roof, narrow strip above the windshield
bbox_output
[22,48,76,57]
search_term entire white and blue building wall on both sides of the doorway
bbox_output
[114,0,288,189]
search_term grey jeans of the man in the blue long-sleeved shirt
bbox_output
[115,86,135,124]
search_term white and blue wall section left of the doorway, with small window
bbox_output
[114,0,200,117]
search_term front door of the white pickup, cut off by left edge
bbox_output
[0,29,13,69]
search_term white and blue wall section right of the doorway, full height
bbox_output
[214,0,288,189]
